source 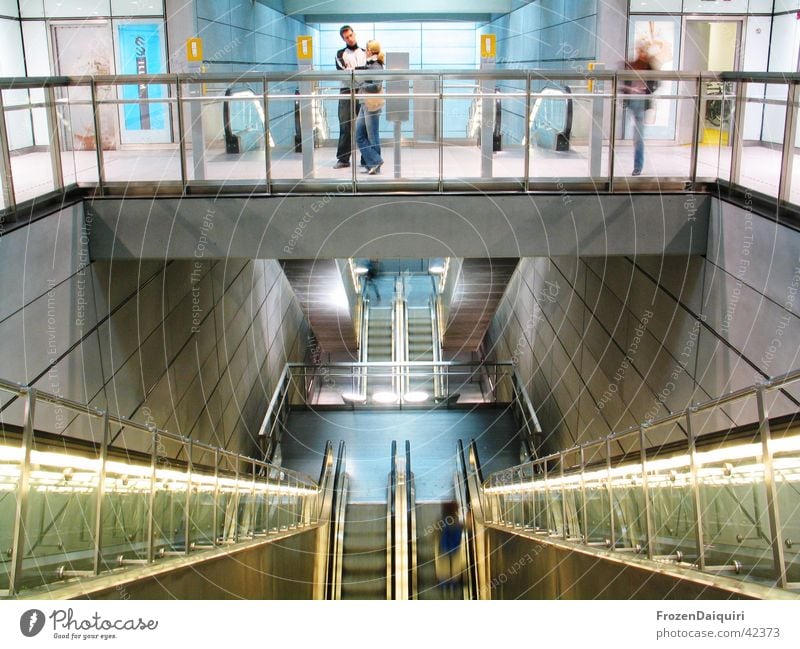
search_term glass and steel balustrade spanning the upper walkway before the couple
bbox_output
[0,70,800,211]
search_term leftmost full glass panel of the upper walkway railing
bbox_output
[2,89,55,203]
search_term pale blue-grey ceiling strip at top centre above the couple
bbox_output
[278,0,511,23]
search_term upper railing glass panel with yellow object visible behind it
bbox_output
[697,81,736,181]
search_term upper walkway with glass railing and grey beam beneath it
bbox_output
[0,70,800,258]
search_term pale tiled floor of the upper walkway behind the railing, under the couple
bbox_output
[4,142,800,203]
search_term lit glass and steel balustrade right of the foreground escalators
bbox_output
[482,370,800,589]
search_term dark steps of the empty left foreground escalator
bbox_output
[342,503,386,599]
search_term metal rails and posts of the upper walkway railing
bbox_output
[0,69,800,214]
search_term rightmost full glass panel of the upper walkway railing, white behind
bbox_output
[734,83,787,197]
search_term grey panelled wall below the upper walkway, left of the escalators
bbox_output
[0,204,308,454]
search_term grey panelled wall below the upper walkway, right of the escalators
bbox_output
[485,195,800,449]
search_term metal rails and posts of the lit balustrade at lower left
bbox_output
[0,380,320,596]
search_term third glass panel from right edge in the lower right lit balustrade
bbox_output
[645,422,697,561]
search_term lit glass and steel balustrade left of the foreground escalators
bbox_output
[0,380,320,596]
